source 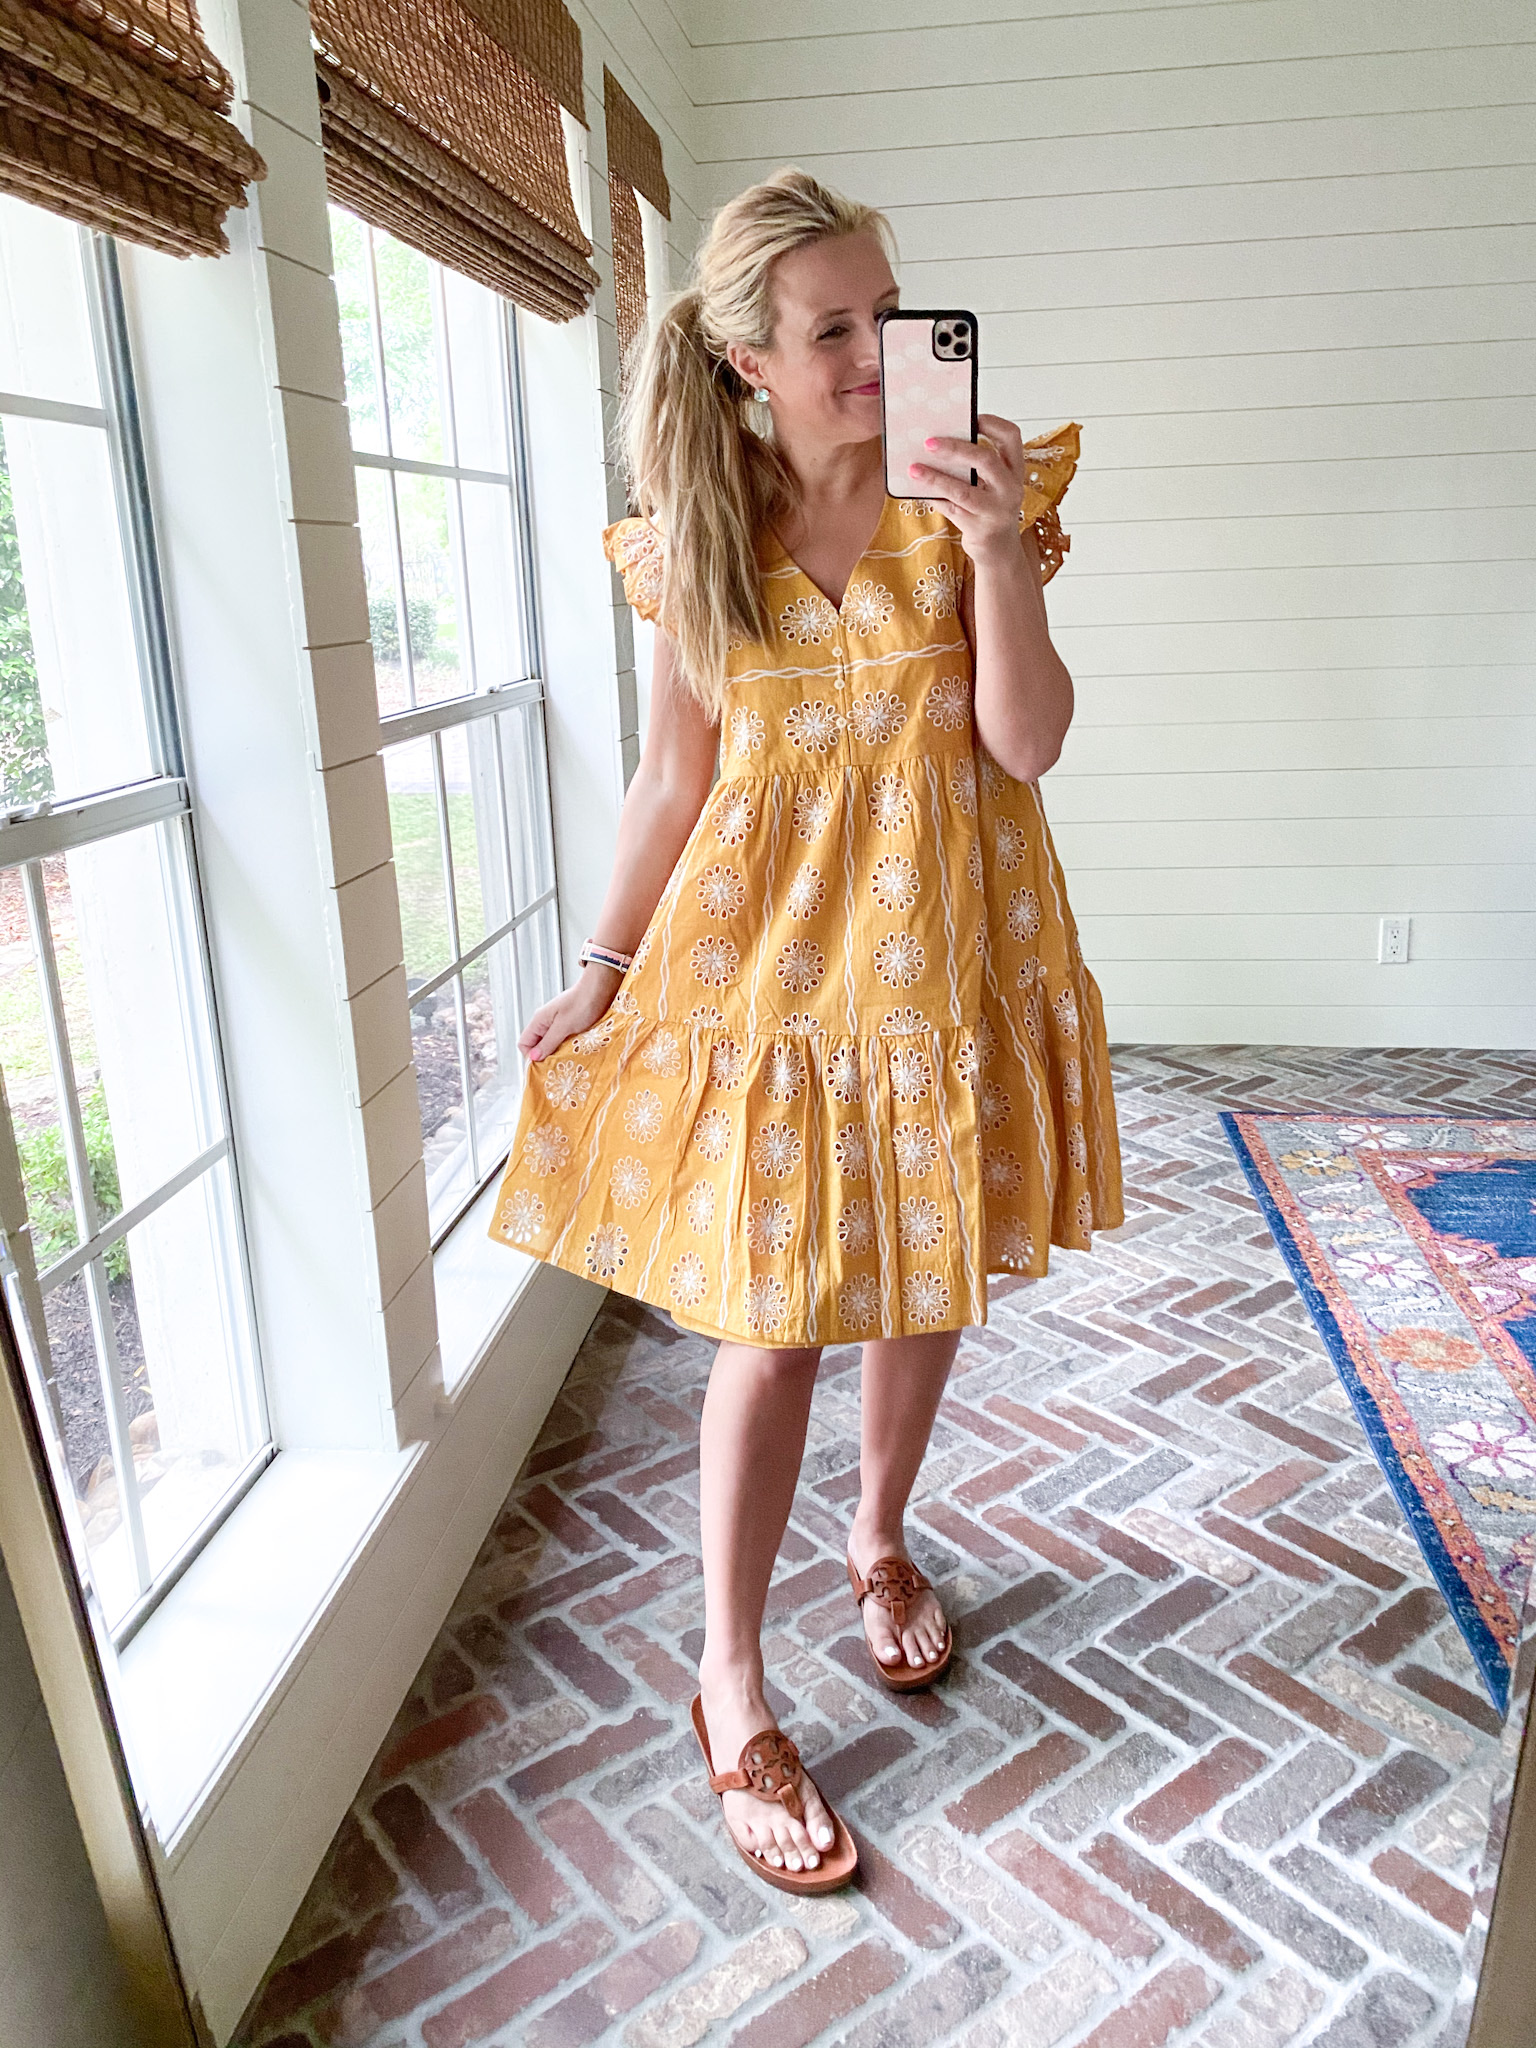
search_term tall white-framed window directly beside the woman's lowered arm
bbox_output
[332,207,561,1241]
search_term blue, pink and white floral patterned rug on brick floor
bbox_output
[1221,1114,1536,1712]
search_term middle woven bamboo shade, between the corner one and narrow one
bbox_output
[313,0,598,319]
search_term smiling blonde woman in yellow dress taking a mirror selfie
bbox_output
[494,170,1120,1890]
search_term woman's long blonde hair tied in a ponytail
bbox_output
[621,166,895,719]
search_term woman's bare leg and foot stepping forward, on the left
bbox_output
[698,1343,831,1870]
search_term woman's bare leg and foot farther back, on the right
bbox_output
[848,1329,963,1665]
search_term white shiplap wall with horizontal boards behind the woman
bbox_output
[667,0,1536,1044]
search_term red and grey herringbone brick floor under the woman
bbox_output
[231,1047,1536,2048]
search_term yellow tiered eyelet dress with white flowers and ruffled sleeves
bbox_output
[492,424,1122,1346]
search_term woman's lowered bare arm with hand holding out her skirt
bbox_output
[518,631,721,1059]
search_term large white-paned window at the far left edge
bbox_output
[0,199,270,1642]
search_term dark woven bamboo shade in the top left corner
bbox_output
[0,0,266,256]
